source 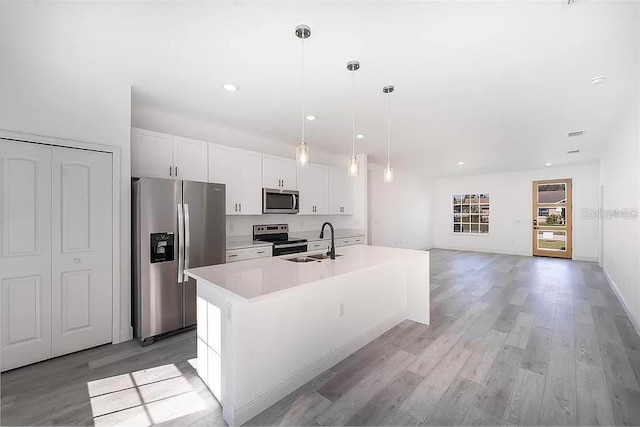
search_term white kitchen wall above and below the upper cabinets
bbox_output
[132,102,367,236]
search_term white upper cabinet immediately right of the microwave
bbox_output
[298,164,329,214]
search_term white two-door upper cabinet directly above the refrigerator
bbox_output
[131,128,207,182]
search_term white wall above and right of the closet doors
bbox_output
[0,3,131,339]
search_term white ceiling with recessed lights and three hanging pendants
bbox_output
[6,0,640,176]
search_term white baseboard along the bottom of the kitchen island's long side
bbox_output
[232,313,406,425]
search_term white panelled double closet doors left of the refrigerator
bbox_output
[0,140,113,371]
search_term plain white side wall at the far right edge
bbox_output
[600,96,640,330]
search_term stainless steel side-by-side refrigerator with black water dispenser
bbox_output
[132,178,226,345]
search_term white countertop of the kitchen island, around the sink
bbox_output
[185,245,427,301]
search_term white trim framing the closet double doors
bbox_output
[0,129,125,344]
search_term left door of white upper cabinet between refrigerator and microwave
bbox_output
[209,144,242,215]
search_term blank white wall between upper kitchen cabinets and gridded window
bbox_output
[368,163,433,249]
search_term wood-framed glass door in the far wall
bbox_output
[532,179,572,258]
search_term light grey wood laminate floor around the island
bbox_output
[0,250,640,425]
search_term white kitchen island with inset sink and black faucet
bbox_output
[186,245,429,425]
